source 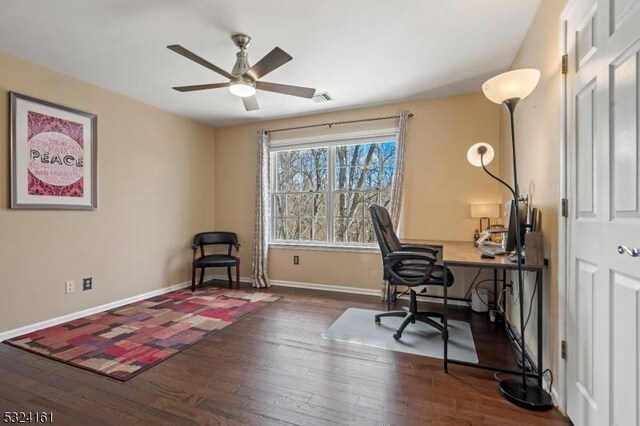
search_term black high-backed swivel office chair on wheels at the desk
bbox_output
[369,204,453,340]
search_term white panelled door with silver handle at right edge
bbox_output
[563,0,640,426]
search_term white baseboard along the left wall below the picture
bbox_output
[0,275,214,342]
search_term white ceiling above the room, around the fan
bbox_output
[0,0,540,126]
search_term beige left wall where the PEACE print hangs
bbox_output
[0,54,214,332]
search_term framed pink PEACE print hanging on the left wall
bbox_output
[9,92,98,210]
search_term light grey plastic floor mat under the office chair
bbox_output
[322,308,478,363]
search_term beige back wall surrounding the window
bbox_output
[215,94,501,289]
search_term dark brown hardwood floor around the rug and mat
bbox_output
[0,287,569,425]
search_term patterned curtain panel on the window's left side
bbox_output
[251,130,271,288]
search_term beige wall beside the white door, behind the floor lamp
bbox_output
[500,0,567,390]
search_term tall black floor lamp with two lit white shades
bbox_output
[467,69,553,410]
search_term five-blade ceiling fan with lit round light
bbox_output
[167,34,316,111]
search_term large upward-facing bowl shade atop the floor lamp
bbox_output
[482,68,540,104]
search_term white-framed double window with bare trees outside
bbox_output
[271,134,396,245]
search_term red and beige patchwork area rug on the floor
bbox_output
[5,288,280,381]
